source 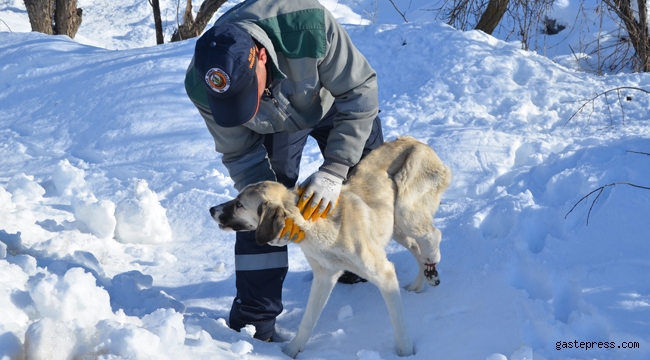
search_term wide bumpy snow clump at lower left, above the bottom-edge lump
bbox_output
[29,268,113,330]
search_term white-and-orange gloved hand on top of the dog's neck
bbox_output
[296,171,343,221]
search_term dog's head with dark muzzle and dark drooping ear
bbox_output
[210,181,295,246]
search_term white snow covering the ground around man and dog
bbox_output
[0,0,650,360]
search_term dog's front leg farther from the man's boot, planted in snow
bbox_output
[368,259,415,356]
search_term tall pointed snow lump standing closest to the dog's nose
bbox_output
[115,180,172,244]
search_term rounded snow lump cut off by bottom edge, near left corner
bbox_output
[24,318,77,360]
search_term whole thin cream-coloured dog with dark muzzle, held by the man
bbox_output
[210,137,451,358]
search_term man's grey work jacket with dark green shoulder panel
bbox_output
[185,0,378,190]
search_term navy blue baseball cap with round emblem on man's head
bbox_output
[194,24,259,127]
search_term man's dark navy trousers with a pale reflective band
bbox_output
[230,110,384,340]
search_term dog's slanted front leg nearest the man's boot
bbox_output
[282,258,341,358]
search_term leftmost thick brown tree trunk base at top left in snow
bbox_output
[24,0,83,39]
